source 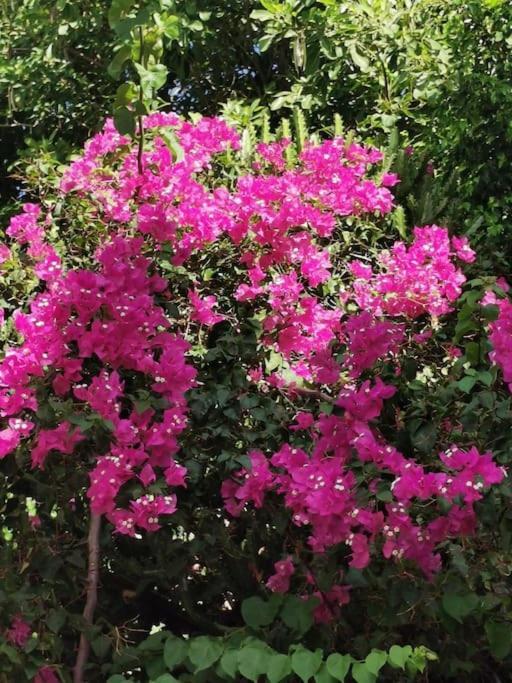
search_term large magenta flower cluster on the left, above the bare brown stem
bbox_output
[0,205,196,535]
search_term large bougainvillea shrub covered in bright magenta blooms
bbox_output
[0,113,510,681]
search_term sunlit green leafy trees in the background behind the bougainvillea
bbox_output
[0,0,512,256]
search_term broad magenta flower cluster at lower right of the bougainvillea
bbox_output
[222,379,504,588]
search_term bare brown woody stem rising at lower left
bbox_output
[73,512,101,683]
